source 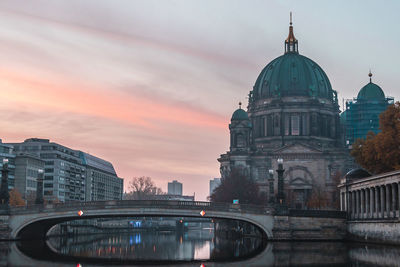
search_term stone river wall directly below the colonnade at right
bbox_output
[347,220,400,245]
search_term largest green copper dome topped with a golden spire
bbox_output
[252,21,334,101]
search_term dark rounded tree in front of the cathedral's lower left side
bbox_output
[210,169,264,205]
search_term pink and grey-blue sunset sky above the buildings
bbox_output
[0,0,400,200]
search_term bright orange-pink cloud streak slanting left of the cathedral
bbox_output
[0,70,226,132]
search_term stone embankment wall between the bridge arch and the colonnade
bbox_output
[272,216,346,240]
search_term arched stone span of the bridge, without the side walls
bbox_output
[10,201,274,239]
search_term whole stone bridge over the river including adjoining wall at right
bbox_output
[0,200,346,240]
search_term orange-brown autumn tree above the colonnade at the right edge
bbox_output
[351,102,400,174]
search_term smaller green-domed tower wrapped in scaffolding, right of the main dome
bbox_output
[340,72,394,146]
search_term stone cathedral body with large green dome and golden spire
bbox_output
[218,19,351,209]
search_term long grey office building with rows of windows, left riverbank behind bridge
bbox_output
[9,138,122,202]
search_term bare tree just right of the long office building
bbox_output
[124,176,164,200]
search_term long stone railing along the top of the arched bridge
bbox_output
[9,200,272,214]
